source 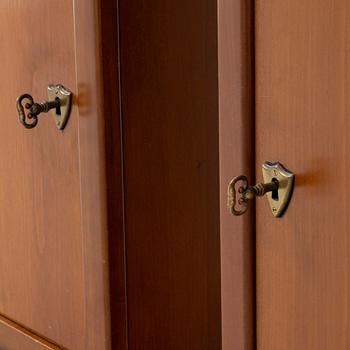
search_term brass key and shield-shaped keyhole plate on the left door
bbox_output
[16,84,72,130]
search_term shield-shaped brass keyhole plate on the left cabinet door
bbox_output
[47,84,72,130]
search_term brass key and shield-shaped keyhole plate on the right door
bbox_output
[227,162,294,217]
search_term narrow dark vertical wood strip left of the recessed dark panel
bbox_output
[101,0,128,350]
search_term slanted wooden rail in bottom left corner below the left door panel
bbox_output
[0,316,64,350]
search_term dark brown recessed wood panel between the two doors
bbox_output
[120,0,221,350]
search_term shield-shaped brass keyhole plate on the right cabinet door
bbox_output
[262,162,294,217]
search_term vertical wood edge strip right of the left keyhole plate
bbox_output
[74,0,111,350]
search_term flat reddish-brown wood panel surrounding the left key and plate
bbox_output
[0,0,84,349]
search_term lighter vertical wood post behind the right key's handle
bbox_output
[218,0,255,350]
